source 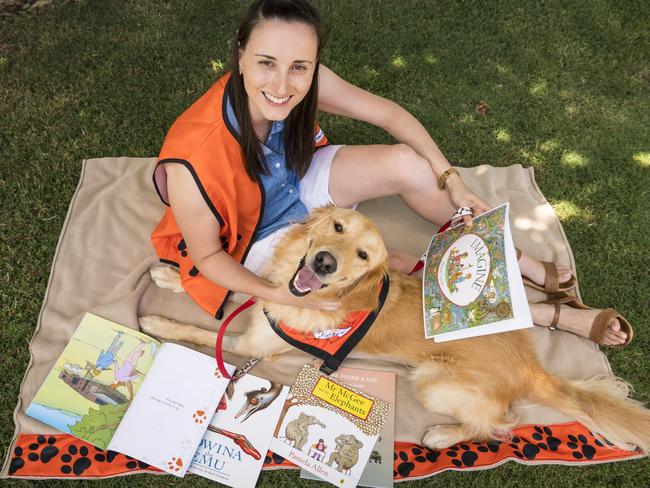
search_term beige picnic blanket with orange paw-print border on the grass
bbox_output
[2,158,640,480]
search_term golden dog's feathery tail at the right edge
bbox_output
[527,370,650,453]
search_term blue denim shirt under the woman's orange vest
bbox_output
[226,99,309,242]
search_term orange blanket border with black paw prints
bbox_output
[9,422,645,481]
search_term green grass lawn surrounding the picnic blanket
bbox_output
[0,0,650,487]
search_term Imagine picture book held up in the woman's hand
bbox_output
[422,203,533,342]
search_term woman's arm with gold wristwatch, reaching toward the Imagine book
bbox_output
[318,65,489,213]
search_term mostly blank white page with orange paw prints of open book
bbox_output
[108,343,234,477]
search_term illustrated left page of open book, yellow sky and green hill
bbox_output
[26,313,160,449]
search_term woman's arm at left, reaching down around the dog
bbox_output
[165,164,338,309]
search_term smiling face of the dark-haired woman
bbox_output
[239,19,318,128]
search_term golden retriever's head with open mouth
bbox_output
[269,206,388,309]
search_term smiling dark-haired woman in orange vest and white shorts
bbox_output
[152,0,626,345]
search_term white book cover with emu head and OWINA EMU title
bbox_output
[188,374,289,488]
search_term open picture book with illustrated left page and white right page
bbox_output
[27,313,234,477]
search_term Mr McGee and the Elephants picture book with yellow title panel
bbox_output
[270,365,391,487]
